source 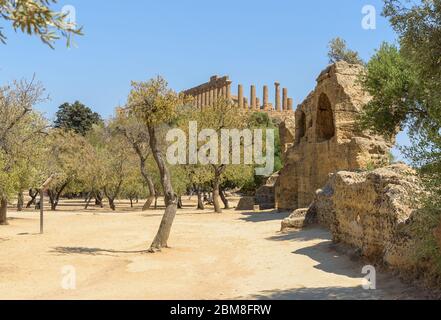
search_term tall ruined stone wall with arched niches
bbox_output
[276,62,393,209]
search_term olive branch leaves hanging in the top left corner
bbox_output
[0,0,82,48]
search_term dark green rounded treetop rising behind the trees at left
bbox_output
[54,101,102,136]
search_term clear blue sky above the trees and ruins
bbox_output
[0,0,407,159]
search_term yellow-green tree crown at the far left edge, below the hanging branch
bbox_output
[0,80,47,197]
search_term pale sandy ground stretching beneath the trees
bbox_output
[0,198,428,299]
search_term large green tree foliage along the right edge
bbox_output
[360,0,441,276]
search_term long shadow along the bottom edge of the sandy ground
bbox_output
[241,286,418,300]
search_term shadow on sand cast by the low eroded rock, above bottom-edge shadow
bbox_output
[293,241,364,279]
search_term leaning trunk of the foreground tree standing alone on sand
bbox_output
[148,126,177,252]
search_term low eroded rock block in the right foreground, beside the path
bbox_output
[306,164,422,268]
